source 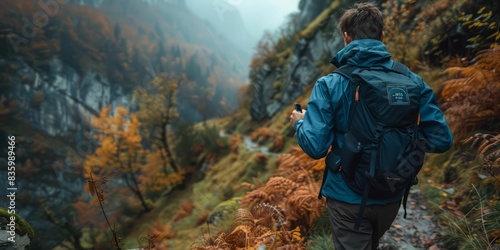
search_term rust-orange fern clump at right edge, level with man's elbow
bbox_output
[441,45,500,139]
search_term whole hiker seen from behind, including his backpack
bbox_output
[290,3,453,250]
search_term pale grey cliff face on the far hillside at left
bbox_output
[0,58,128,136]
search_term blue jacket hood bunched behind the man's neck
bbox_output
[330,39,391,68]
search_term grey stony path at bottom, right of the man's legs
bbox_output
[379,188,440,250]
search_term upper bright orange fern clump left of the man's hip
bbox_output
[240,147,325,235]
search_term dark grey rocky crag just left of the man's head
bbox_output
[250,0,343,120]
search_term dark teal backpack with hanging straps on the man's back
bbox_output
[325,62,425,230]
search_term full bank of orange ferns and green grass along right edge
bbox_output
[434,41,500,249]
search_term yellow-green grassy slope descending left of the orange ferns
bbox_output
[120,86,310,249]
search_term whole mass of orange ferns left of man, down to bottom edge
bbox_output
[192,147,325,249]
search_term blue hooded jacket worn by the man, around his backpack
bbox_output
[294,39,453,205]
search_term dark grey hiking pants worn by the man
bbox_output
[327,199,400,250]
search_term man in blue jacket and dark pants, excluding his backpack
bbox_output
[290,3,453,250]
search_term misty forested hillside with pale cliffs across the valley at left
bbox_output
[0,0,248,249]
